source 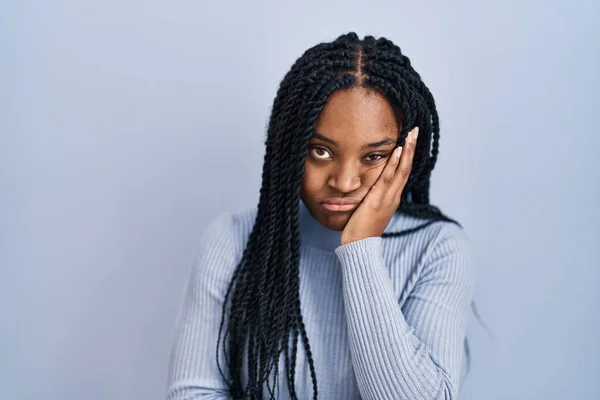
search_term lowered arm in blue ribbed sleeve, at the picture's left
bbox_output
[167,214,237,400]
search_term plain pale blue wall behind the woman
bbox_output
[0,0,600,400]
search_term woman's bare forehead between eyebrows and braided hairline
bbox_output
[317,87,398,144]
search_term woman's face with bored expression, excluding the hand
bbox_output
[301,87,399,231]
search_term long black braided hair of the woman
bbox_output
[217,32,468,399]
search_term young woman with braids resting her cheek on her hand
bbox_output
[168,33,474,400]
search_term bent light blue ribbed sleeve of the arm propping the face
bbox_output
[335,223,474,400]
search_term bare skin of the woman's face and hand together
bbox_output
[301,87,418,244]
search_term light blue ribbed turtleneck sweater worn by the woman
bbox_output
[168,201,474,400]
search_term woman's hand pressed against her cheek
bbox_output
[342,127,419,244]
